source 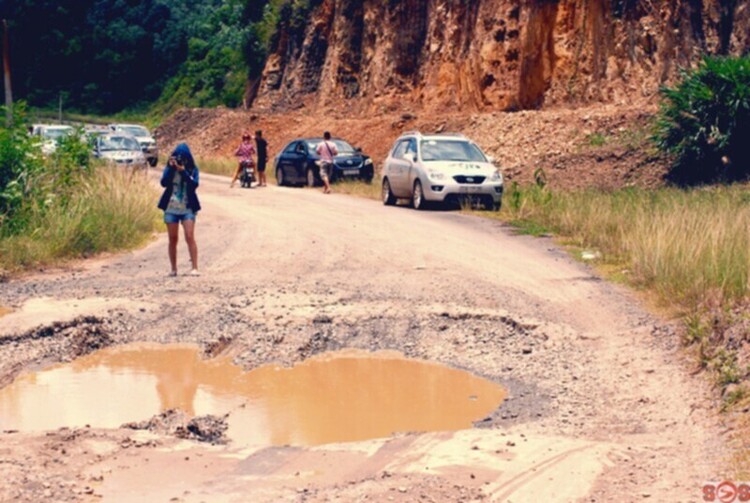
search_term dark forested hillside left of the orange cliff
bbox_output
[0,0,281,114]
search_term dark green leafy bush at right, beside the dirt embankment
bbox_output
[654,56,750,184]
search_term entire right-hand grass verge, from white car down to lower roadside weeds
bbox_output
[482,185,750,476]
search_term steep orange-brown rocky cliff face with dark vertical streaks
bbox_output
[254,0,750,111]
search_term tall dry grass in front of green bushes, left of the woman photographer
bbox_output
[0,166,159,270]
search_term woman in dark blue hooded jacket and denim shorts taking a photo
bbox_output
[159,143,201,276]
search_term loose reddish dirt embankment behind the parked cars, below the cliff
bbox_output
[158,105,666,188]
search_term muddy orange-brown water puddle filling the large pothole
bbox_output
[0,344,506,445]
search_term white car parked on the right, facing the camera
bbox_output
[382,132,503,211]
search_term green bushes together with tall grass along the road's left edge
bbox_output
[0,106,158,270]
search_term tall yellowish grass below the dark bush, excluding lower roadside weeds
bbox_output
[505,186,750,309]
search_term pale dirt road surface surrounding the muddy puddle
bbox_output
[0,171,726,501]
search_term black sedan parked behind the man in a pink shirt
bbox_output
[274,138,375,187]
